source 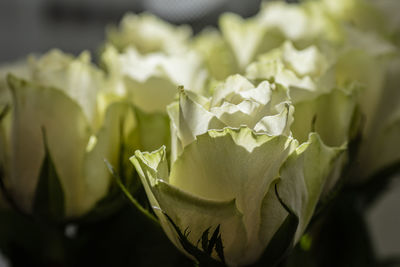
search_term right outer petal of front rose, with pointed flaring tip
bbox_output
[276,133,345,242]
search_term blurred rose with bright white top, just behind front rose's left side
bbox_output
[103,48,207,113]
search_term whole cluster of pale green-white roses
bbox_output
[0,0,400,266]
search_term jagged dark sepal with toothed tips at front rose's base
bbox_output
[163,212,226,267]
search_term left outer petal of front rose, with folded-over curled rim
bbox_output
[131,148,246,264]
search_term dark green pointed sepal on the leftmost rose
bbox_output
[33,129,65,222]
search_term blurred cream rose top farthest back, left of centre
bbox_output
[107,13,192,54]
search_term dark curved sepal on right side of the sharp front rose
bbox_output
[251,184,299,267]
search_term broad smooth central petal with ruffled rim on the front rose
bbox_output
[169,128,293,263]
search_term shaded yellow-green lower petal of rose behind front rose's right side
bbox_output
[291,89,356,146]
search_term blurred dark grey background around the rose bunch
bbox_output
[0,0,400,267]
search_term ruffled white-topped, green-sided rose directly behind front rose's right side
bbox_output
[247,42,358,146]
